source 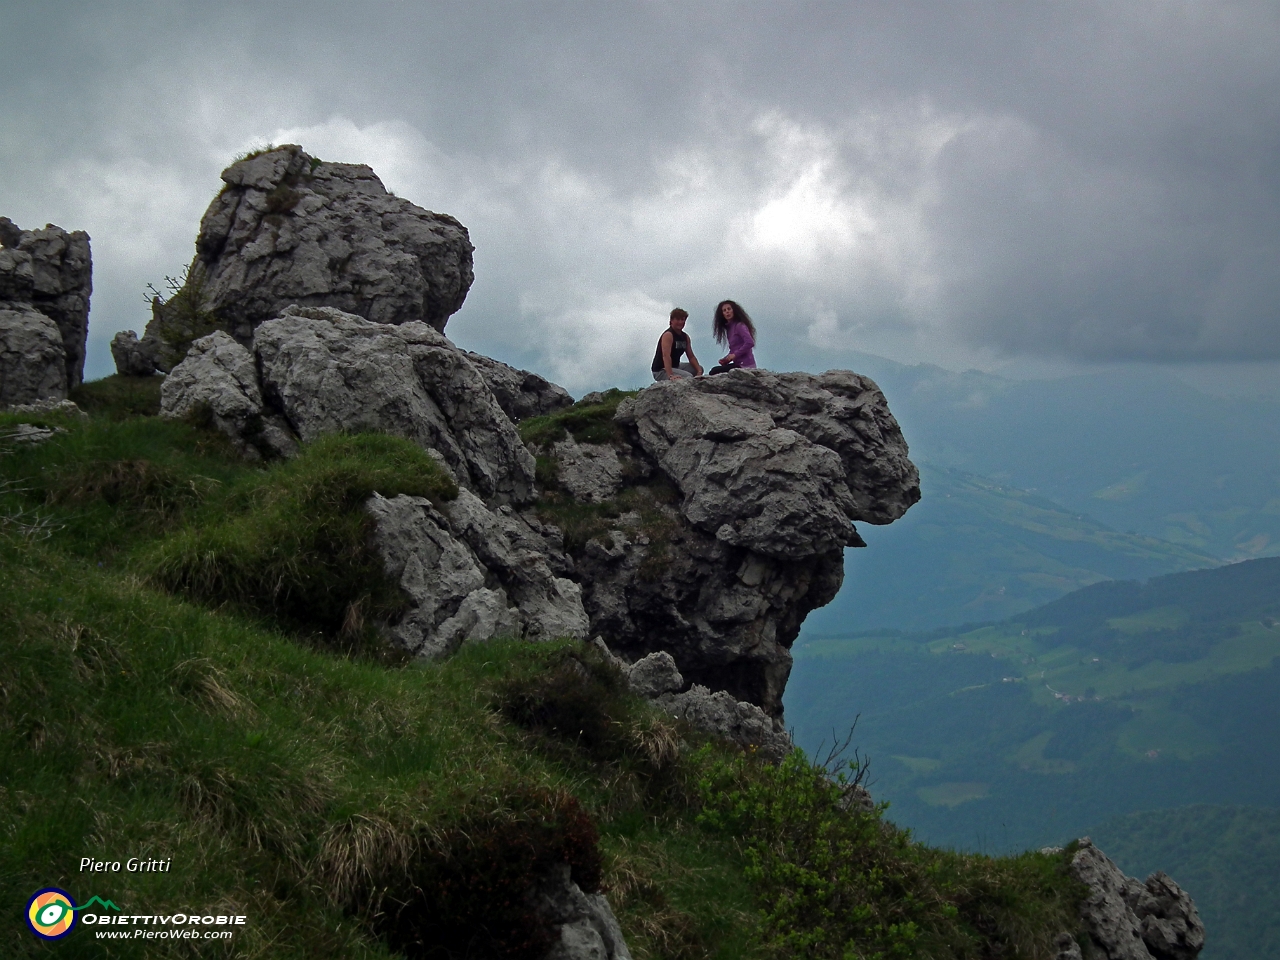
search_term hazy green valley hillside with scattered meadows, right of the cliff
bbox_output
[786,558,1280,849]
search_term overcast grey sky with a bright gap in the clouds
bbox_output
[0,0,1280,393]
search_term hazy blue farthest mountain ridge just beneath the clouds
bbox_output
[841,353,1280,559]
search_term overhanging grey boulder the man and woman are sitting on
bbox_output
[617,370,920,537]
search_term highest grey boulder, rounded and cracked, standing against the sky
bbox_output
[132,145,474,370]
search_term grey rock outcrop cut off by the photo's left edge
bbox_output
[0,216,93,406]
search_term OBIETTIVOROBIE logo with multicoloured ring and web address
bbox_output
[27,887,248,940]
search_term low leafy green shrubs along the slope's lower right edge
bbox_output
[698,750,1084,960]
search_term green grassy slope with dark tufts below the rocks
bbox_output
[0,379,1100,957]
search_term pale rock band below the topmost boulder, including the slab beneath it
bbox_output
[160,307,588,657]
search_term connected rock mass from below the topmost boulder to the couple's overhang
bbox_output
[161,306,919,721]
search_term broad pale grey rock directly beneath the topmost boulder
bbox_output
[161,307,534,503]
